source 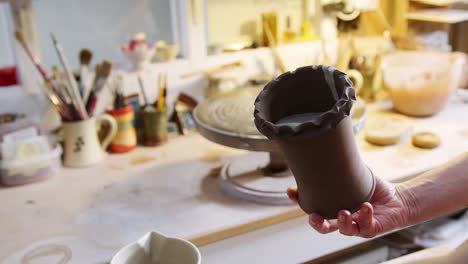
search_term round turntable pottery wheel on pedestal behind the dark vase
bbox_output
[193,87,366,204]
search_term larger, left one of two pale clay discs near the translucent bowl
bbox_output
[365,116,411,146]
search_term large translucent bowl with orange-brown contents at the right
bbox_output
[382,51,465,116]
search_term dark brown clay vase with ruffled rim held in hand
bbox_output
[254,66,375,219]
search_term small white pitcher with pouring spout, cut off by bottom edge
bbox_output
[110,232,201,264]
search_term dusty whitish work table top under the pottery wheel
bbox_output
[0,102,468,264]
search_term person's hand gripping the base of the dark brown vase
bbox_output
[287,177,409,238]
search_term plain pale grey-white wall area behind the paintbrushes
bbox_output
[33,0,174,69]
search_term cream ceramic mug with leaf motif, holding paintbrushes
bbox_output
[63,114,117,167]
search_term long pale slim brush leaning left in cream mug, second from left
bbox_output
[50,33,89,120]
